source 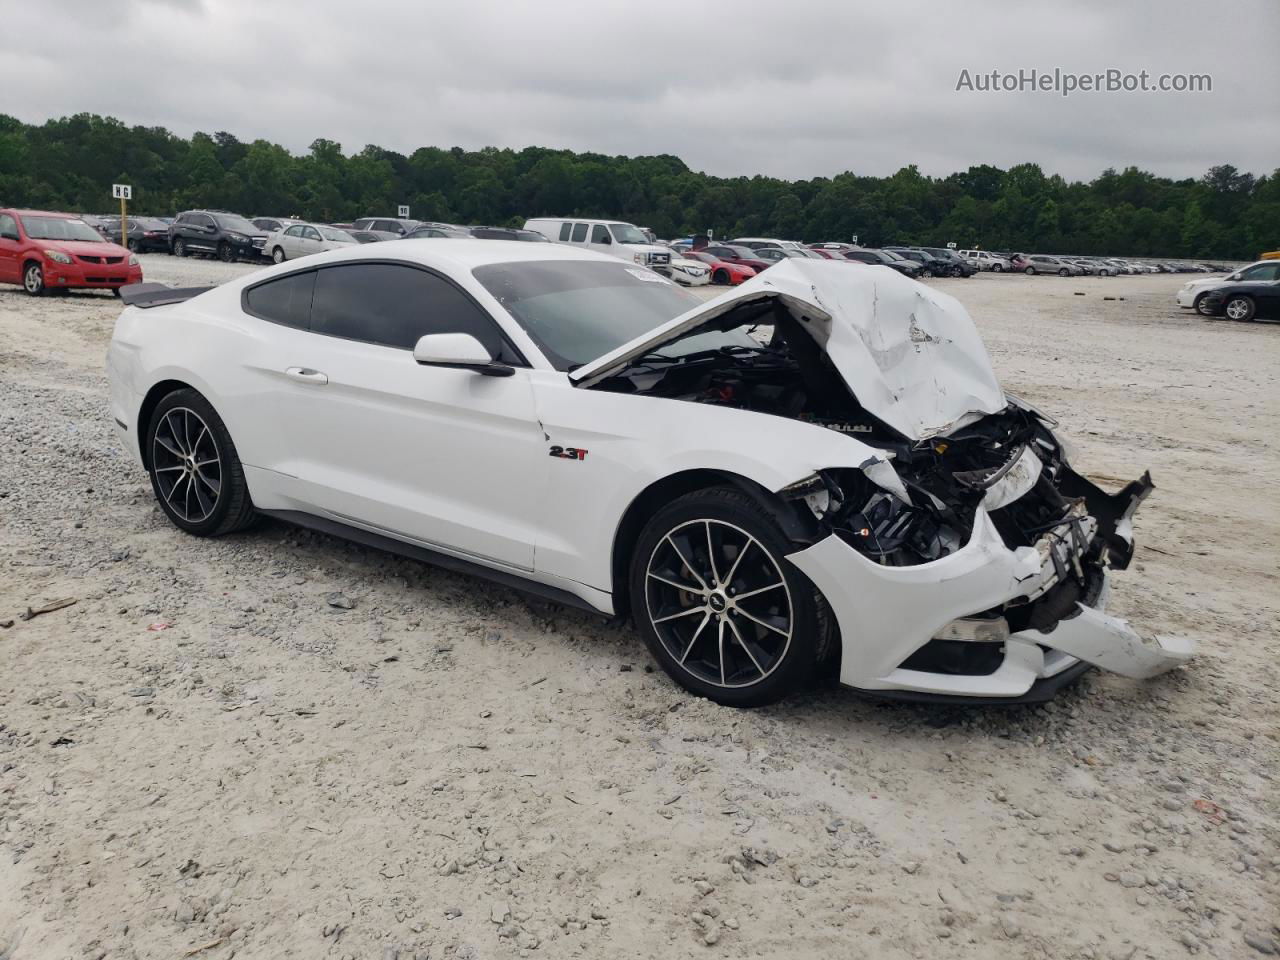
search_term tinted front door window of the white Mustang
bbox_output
[311,264,520,362]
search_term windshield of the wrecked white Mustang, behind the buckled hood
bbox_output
[472,260,759,371]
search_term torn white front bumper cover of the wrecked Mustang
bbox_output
[788,472,1194,701]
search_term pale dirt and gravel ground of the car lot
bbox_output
[0,255,1280,960]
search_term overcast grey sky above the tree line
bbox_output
[0,0,1280,179]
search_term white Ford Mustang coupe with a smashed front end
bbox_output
[108,239,1192,705]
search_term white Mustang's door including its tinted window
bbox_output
[262,261,547,571]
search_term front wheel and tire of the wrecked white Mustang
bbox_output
[630,486,831,707]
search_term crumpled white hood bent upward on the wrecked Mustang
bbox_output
[570,259,1007,440]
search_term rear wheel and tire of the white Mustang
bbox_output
[145,388,253,536]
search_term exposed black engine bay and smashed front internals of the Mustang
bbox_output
[598,302,1152,660]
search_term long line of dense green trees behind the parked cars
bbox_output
[0,114,1280,260]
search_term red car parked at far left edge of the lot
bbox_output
[0,210,142,297]
